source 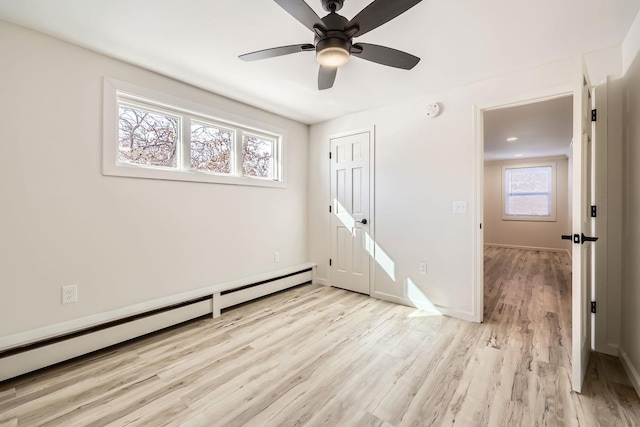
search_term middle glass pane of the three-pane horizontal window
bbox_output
[191,122,234,174]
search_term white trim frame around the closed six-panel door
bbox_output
[327,126,376,295]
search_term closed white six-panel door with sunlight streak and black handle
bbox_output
[329,132,373,295]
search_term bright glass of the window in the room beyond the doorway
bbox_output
[505,166,552,217]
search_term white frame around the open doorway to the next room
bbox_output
[472,84,574,323]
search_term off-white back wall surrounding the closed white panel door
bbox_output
[309,60,573,319]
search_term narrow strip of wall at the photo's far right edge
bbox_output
[620,15,640,393]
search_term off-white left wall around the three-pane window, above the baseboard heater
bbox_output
[0,22,308,338]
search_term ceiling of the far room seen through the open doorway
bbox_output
[484,96,573,160]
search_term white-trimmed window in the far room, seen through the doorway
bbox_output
[502,163,556,221]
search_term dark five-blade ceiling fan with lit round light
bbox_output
[239,0,422,90]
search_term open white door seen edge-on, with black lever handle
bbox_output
[571,59,596,392]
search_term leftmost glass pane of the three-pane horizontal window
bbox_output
[118,105,178,168]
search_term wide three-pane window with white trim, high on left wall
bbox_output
[103,79,284,187]
